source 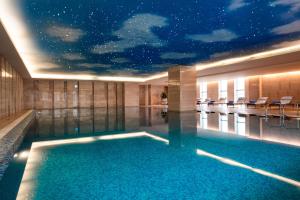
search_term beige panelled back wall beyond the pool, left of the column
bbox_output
[24,80,126,109]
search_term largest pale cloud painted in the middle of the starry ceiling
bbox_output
[92,14,167,54]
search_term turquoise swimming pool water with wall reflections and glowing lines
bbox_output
[0,109,300,200]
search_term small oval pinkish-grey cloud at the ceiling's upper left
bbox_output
[46,25,86,42]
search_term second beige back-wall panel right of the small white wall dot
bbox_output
[94,81,107,108]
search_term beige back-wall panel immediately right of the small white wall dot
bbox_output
[78,81,94,108]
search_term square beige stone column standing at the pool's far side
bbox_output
[168,67,197,111]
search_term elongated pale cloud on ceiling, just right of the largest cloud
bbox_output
[186,29,238,43]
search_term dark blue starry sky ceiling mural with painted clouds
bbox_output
[1,0,300,77]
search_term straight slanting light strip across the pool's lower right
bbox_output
[196,149,300,187]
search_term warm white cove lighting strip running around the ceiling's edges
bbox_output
[0,0,300,82]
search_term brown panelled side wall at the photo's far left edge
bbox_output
[0,56,23,118]
